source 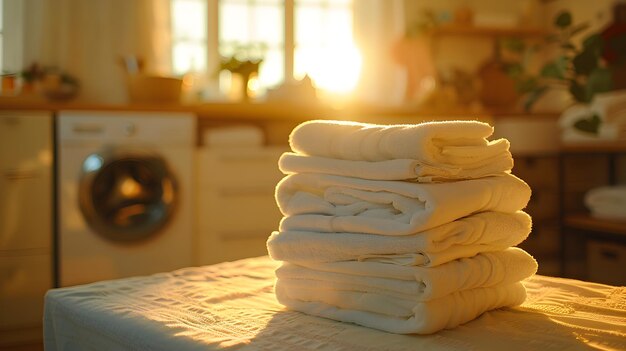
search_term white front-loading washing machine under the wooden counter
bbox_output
[57,111,196,286]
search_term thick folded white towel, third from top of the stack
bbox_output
[275,173,530,235]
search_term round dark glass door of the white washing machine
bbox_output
[79,149,178,242]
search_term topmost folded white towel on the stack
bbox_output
[289,120,509,168]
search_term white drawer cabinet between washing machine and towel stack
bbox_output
[196,147,286,265]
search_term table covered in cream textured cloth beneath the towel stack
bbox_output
[44,257,626,351]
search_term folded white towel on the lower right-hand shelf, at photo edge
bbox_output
[585,185,626,220]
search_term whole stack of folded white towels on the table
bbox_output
[267,121,537,334]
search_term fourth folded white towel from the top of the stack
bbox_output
[267,211,531,266]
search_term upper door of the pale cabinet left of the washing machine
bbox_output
[0,112,52,251]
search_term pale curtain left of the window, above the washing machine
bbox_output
[24,0,171,103]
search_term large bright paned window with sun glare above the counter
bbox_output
[171,0,360,99]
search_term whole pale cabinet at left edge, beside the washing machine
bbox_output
[0,111,53,347]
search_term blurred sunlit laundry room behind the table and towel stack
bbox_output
[0,0,626,350]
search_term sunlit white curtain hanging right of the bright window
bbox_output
[354,0,406,105]
